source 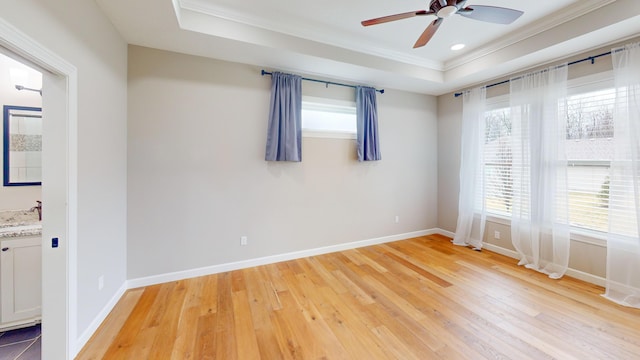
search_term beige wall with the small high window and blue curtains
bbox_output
[128,46,437,279]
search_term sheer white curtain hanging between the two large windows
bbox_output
[510,65,569,279]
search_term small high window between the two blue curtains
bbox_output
[302,97,356,139]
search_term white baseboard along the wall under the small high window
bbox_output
[127,229,439,289]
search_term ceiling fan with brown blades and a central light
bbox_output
[362,0,524,49]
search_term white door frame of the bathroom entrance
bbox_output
[0,18,78,359]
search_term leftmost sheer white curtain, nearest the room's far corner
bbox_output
[453,87,487,249]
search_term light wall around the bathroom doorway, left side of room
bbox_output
[0,0,127,348]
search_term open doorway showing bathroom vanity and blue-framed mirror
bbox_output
[0,53,42,359]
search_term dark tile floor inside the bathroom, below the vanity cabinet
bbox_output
[0,324,42,360]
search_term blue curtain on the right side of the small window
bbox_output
[356,86,382,161]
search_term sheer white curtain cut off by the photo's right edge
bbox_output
[604,43,640,308]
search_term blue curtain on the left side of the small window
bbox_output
[265,72,302,161]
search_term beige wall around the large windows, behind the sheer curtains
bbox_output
[438,40,638,277]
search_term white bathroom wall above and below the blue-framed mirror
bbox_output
[0,54,42,211]
